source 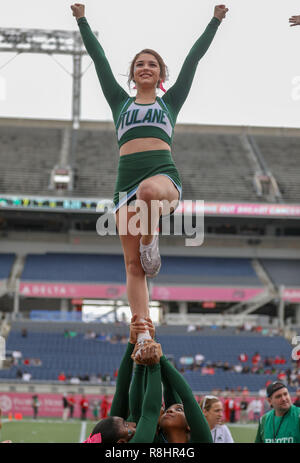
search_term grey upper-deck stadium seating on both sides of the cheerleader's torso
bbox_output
[0,123,300,203]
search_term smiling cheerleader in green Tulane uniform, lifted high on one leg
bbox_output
[71,3,228,358]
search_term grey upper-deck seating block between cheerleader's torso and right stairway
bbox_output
[173,133,259,202]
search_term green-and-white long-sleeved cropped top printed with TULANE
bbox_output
[78,17,220,146]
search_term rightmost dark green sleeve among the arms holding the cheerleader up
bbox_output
[160,355,212,443]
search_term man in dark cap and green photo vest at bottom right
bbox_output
[255,381,300,444]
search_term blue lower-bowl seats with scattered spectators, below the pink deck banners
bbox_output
[0,328,292,391]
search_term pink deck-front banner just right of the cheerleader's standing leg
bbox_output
[151,286,264,302]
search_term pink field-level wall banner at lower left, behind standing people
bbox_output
[0,392,113,419]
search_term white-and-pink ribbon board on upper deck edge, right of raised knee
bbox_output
[175,201,300,217]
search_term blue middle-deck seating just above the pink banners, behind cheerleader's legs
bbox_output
[21,253,262,287]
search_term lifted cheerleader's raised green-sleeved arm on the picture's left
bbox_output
[71,3,128,114]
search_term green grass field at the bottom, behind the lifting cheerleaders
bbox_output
[0,419,257,443]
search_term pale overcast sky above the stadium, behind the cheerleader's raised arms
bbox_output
[0,0,300,128]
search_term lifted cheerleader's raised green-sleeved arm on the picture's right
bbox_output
[162,5,228,117]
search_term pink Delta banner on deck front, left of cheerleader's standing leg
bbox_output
[19,282,126,299]
